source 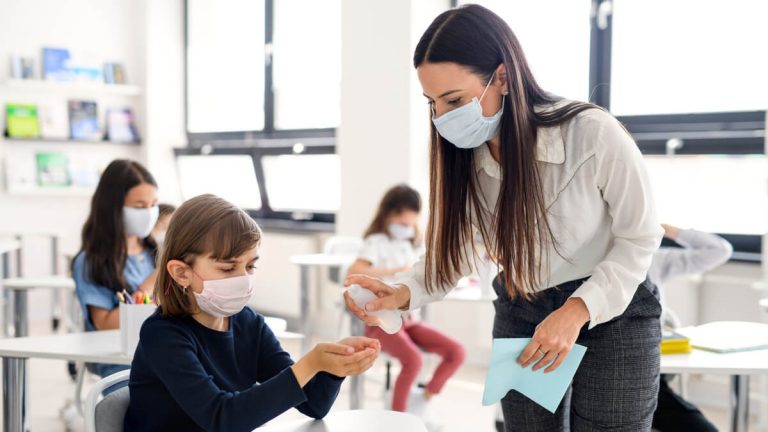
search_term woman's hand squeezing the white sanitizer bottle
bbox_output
[344,275,411,326]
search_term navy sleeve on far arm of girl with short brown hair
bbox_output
[258,316,344,419]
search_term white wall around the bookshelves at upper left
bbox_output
[0,0,145,280]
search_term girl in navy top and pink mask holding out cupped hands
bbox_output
[124,195,379,432]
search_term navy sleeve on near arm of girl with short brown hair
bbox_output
[140,318,314,432]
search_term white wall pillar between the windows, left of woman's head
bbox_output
[337,0,449,235]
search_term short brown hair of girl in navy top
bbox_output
[154,195,261,316]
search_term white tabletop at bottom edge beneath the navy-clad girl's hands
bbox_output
[254,410,427,432]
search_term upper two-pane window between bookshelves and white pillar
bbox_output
[186,0,341,138]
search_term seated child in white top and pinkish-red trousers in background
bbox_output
[349,185,465,415]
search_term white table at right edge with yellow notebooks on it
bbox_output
[661,340,768,432]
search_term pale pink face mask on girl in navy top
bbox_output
[192,270,256,318]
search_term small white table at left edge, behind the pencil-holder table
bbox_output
[3,276,75,337]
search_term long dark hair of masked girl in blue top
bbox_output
[73,159,157,292]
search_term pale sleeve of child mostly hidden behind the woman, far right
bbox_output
[651,230,733,284]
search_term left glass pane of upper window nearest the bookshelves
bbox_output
[187,0,265,133]
